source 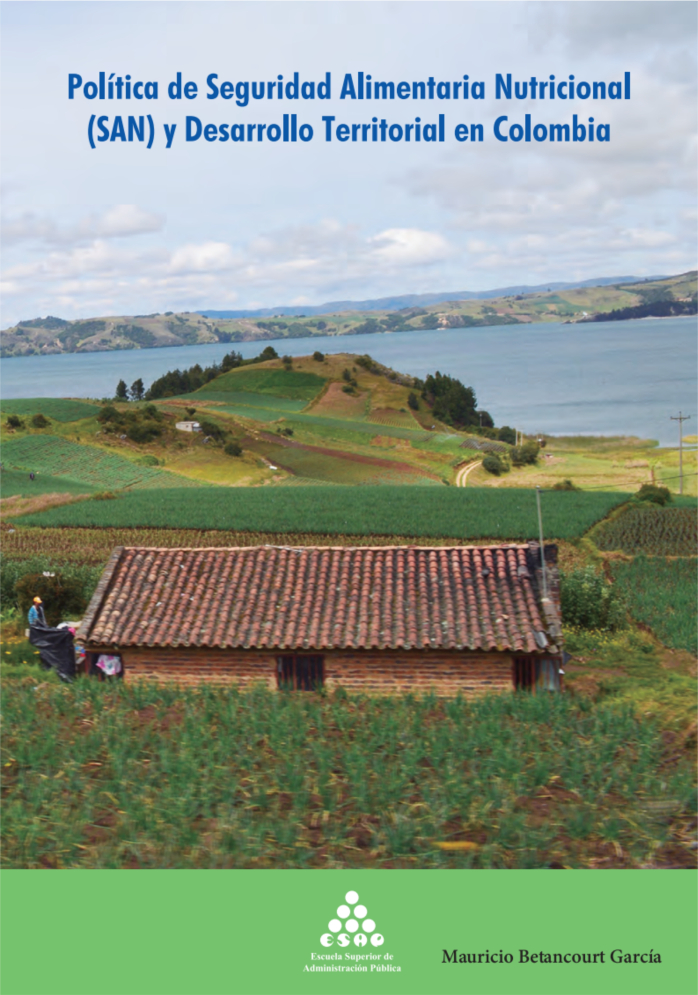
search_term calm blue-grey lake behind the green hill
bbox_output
[1,317,698,445]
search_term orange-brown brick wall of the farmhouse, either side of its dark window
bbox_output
[90,647,513,696]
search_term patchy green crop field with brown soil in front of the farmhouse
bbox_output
[2,680,694,868]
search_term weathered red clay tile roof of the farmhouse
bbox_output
[78,545,549,652]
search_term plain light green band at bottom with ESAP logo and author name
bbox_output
[0,870,698,995]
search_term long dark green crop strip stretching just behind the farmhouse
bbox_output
[16,486,624,540]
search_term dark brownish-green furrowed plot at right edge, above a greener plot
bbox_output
[591,501,698,556]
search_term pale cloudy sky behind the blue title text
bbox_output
[0,0,698,327]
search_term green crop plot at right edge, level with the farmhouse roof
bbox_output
[610,556,698,654]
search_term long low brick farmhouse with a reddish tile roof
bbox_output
[76,544,562,695]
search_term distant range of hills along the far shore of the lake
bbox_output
[0,271,696,357]
